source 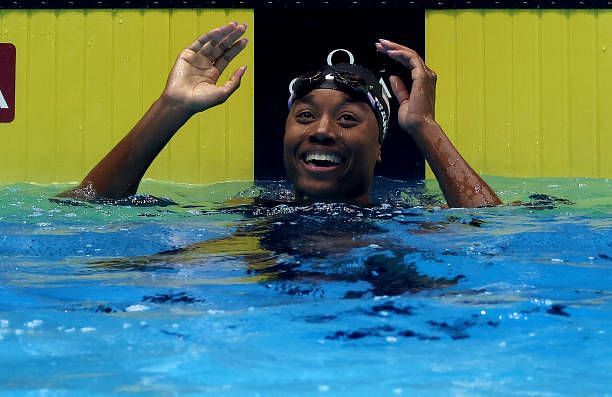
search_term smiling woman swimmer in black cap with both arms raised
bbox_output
[60,22,501,207]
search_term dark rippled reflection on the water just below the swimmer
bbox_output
[92,184,468,298]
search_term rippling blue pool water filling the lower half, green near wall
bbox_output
[0,178,612,396]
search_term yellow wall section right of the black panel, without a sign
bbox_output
[426,10,612,177]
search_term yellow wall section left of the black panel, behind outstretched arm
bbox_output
[0,9,253,183]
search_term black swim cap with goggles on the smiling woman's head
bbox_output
[288,63,390,143]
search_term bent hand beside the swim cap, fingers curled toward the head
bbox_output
[376,39,437,135]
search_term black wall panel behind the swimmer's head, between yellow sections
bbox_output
[255,5,425,180]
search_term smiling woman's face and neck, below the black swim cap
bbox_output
[283,89,381,205]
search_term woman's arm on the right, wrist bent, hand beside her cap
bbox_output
[376,40,501,207]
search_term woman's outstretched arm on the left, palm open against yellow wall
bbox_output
[59,22,247,200]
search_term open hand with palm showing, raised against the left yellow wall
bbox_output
[162,22,247,113]
